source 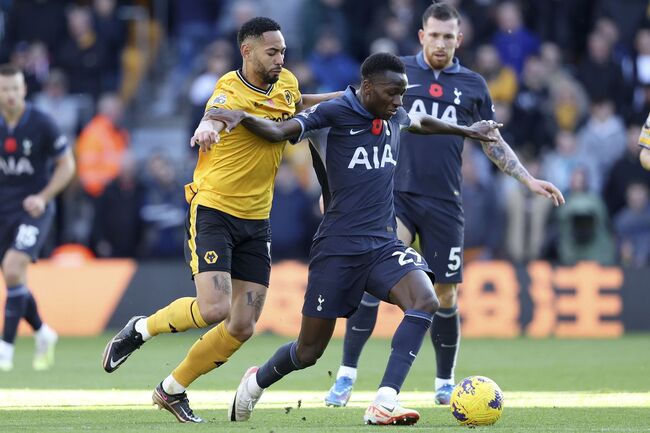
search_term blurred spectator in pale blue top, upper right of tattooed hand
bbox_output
[578,99,625,186]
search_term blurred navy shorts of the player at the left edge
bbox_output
[0,203,54,262]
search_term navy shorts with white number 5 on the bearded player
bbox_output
[395,191,465,284]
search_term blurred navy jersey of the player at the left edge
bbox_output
[0,104,68,213]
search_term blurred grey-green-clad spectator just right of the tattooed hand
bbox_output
[557,167,616,265]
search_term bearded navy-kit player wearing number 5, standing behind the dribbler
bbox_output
[325,3,564,406]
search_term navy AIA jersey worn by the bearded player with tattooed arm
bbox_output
[395,52,494,202]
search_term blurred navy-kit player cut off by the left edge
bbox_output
[0,65,75,371]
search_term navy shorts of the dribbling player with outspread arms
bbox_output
[302,236,433,319]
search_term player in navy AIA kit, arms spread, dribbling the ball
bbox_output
[208,53,494,424]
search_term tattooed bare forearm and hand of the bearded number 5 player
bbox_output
[481,129,564,206]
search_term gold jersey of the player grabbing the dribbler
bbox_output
[185,69,302,220]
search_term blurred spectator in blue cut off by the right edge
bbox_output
[614,183,650,267]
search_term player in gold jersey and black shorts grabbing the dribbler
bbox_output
[103,18,338,422]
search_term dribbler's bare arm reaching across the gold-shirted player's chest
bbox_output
[205,108,301,143]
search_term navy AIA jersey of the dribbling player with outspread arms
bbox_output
[294,87,411,242]
